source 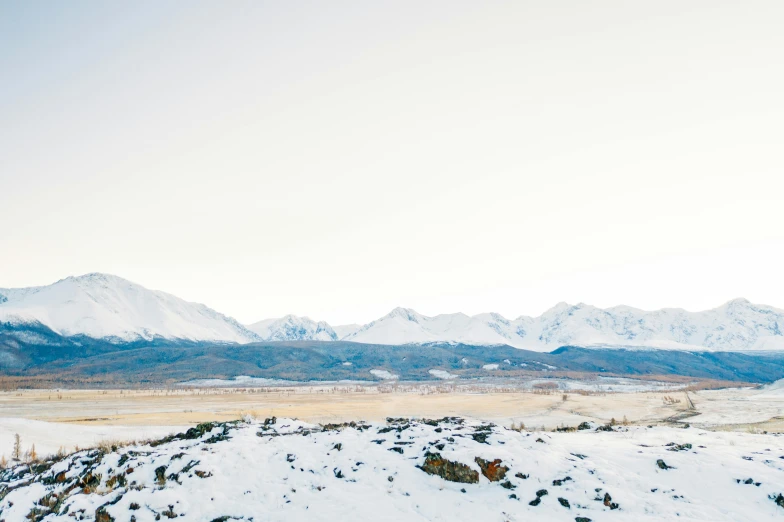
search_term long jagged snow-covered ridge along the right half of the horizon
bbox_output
[343,299,784,351]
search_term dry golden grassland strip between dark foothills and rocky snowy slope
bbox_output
[0,385,760,429]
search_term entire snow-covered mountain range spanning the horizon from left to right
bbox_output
[0,274,784,351]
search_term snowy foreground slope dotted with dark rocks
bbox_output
[0,418,784,522]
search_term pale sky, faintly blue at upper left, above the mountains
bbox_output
[0,0,784,324]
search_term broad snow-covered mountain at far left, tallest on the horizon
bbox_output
[0,274,259,343]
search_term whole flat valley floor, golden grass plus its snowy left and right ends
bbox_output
[0,384,784,458]
